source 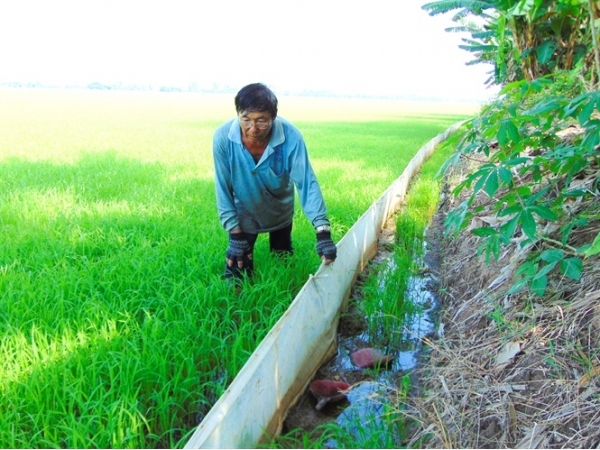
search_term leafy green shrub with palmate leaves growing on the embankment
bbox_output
[445,79,600,296]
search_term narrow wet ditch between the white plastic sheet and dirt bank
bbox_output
[282,212,439,448]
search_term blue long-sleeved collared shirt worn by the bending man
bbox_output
[213,117,329,234]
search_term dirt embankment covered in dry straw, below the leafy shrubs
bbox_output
[406,155,600,448]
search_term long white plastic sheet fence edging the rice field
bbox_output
[185,123,462,448]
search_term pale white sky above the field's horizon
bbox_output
[0,0,497,101]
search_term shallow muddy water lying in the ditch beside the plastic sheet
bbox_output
[283,230,438,448]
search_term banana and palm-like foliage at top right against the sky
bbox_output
[422,0,600,86]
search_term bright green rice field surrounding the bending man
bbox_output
[0,89,477,448]
